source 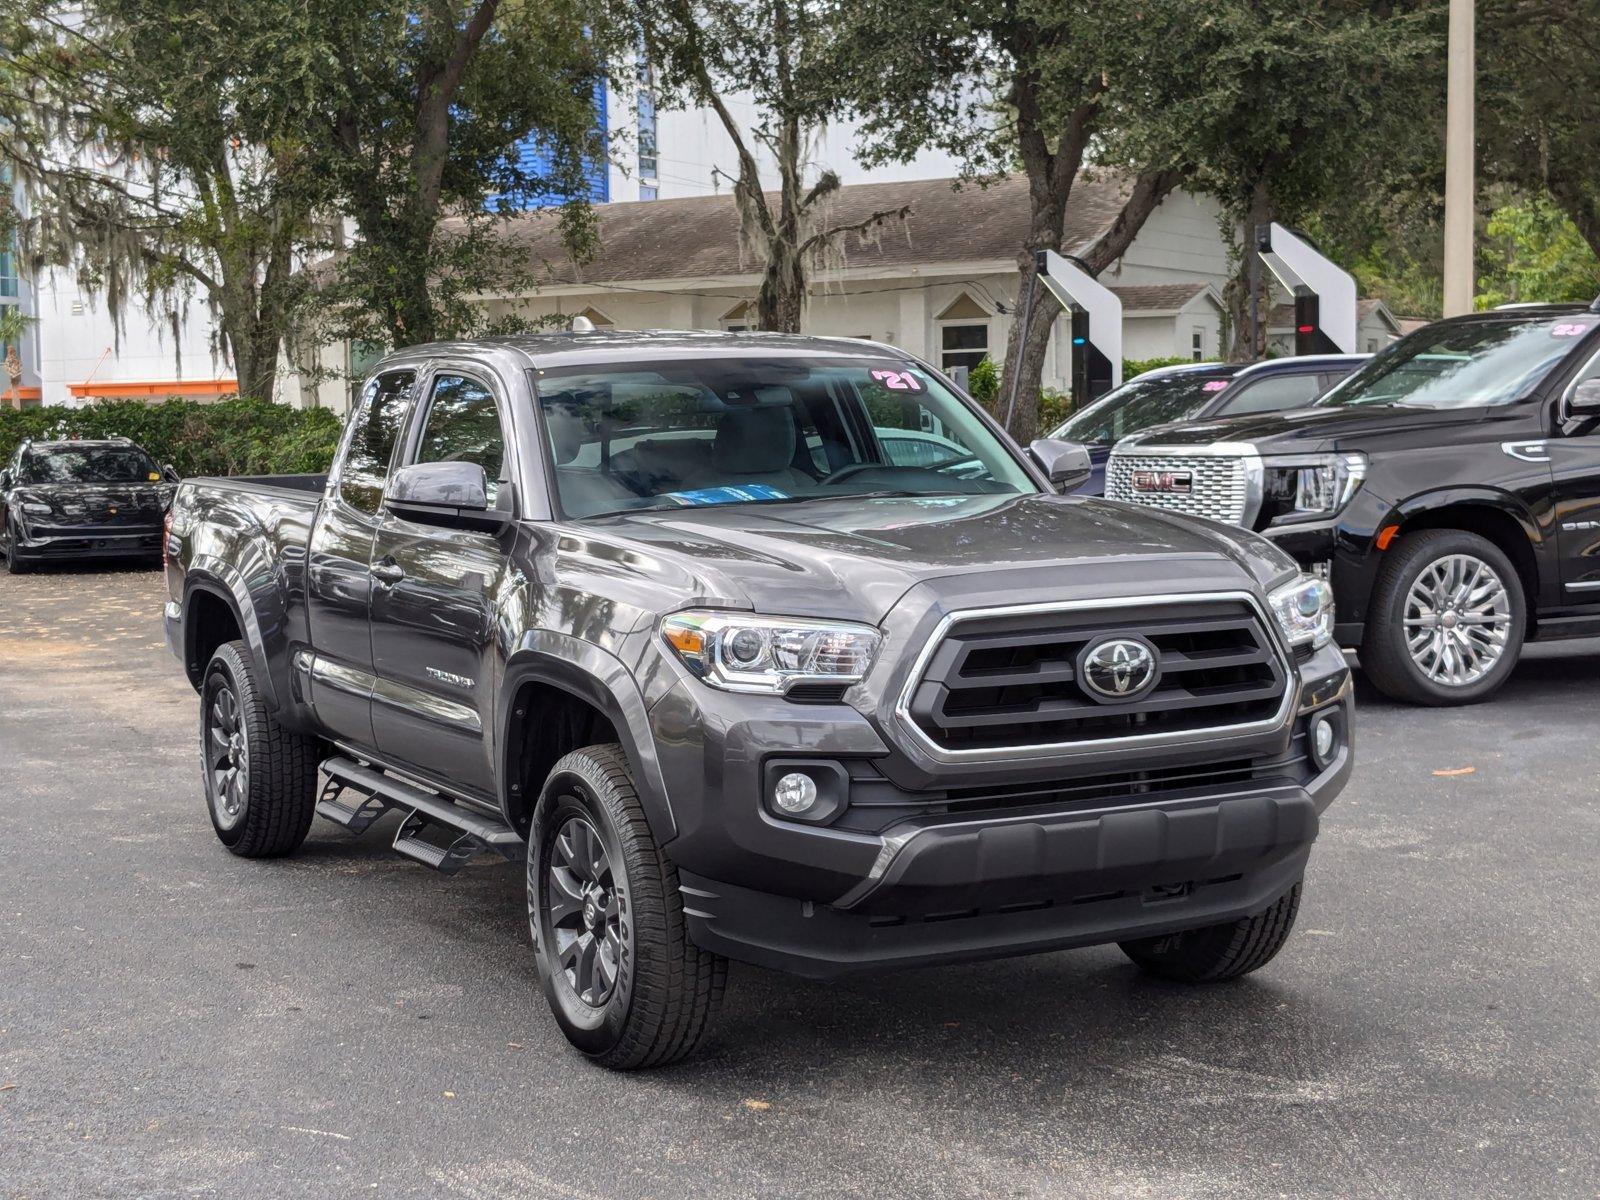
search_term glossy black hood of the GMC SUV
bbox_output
[1117,405,1485,454]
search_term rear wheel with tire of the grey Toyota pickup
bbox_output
[200,642,317,858]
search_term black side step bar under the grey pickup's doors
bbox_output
[317,755,525,875]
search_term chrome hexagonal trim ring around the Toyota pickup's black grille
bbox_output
[894,592,1299,763]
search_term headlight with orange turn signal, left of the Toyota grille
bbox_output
[661,611,882,694]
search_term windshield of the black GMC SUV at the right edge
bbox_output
[1317,314,1600,408]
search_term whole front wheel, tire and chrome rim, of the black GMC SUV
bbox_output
[1362,530,1528,704]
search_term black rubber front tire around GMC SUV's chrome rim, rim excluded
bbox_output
[1360,530,1528,706]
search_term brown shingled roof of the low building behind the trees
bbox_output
[483,173,1130,283]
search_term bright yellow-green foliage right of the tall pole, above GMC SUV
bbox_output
[1477,197,1600,309]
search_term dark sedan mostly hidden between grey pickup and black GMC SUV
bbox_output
[1050,354,1368,496]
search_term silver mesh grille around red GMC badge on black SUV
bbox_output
[1106,434,1266,530]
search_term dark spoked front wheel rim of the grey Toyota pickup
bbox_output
[544,816,624,1008]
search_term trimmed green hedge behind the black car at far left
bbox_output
[0,398,339,477]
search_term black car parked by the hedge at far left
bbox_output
[0,438,178,574]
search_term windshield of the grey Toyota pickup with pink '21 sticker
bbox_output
[539,358,1037,517]
